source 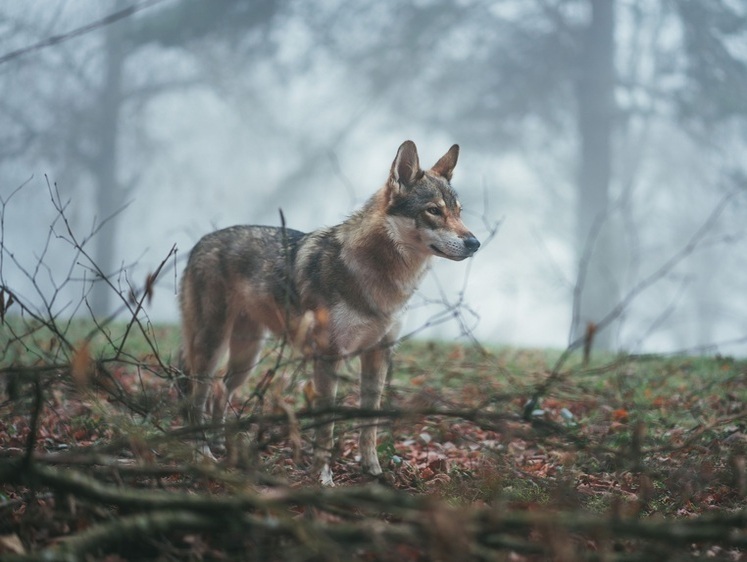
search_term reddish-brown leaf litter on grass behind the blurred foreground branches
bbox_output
[0,334,747,560]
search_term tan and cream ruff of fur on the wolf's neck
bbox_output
[337,188,430,313]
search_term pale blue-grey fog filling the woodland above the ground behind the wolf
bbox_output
[0,0,747,355]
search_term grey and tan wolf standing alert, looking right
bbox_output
[180,140,480,485]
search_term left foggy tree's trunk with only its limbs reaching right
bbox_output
[90,0,278,317]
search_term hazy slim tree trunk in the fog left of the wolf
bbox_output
[89,12,125,317]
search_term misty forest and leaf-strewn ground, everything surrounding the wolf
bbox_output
[0,0,747,562]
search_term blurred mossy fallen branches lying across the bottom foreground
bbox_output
[5,461,747,561]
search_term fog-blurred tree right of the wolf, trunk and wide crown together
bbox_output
[307,0,747,347]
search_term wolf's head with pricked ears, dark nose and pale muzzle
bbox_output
[386,141,480,261]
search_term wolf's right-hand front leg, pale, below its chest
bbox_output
[358,346,391,476]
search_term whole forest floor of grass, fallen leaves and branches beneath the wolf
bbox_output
[0,320,747,562]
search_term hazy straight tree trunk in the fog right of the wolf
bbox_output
[571,0,620,348]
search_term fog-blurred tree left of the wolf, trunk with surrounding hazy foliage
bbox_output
[0,0,281,317]
